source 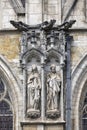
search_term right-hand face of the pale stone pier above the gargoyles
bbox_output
[43,0,61,24]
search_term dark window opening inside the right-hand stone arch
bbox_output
[78,80,87,130]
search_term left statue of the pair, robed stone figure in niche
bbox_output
[27,65,41,117]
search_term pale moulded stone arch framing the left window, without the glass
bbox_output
[0,55,23,130]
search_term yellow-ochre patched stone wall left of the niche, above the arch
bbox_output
[0,31,22,85]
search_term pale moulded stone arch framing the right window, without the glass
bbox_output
[71,54,87,130]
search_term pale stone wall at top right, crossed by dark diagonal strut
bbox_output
[62,0,87,28]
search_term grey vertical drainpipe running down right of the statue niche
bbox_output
[66,36,72,130]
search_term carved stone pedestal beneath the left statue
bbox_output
[27,109,40,118]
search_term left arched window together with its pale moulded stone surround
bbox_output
[0,55,23,130]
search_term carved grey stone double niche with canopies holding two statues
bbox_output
[20,19,66,130]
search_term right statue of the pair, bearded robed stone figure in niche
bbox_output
[47,65,61,118]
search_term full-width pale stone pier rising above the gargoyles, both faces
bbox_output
[26,0,61,25]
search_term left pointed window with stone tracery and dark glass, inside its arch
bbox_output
[0,78,13,130]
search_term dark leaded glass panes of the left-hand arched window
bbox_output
[0,81,13,130]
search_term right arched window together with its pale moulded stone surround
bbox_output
[72,55,87,130]
